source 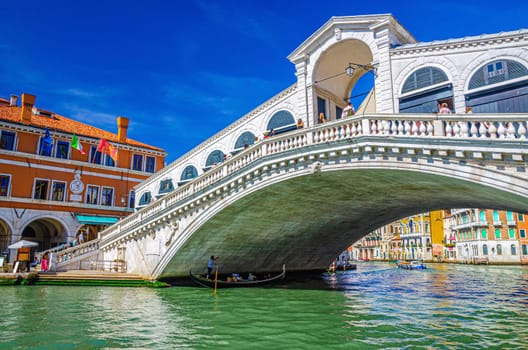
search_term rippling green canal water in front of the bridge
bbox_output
[0,263,528,349]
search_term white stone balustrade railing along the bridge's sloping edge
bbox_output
[100,114,528,242]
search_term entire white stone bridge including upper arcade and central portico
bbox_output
[51,14,528,278]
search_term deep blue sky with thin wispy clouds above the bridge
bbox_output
[0,0,528,162]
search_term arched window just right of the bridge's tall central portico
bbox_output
[400,67,453,113]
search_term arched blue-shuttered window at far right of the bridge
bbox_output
[466,60,528,113]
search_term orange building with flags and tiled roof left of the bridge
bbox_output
[0,94,166,260]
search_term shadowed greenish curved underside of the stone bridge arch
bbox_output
[160,169,528,278]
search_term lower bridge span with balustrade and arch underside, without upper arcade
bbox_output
[96,115,528,278]
